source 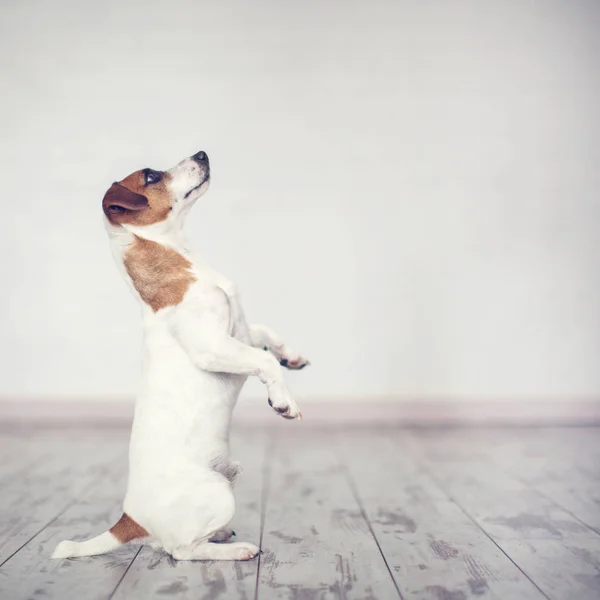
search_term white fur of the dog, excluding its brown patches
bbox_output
[55,159,308,560]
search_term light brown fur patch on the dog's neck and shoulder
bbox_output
[124,236,196,312]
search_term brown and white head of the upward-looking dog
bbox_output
[102,151,210,227]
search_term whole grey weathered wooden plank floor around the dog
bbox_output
[0,422,600,600]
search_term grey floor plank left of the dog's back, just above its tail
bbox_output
[0,436,126,565]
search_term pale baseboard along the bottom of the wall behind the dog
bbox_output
[0,397,600,428]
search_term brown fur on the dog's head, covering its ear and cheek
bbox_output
[102,169,173,226]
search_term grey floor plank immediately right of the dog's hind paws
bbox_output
[258,423,398,600]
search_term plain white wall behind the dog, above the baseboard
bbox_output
[0,0,600,398]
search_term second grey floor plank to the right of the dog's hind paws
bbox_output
[338,432,544,600]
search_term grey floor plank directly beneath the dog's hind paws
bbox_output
[113,431,267,600]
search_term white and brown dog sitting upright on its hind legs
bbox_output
[53,152,309,560]
